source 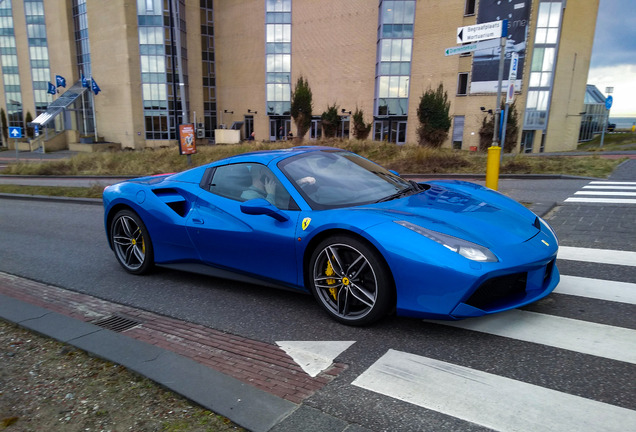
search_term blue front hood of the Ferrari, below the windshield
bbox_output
[358,182,541,246]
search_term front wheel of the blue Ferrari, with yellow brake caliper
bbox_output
[307,236,395,326]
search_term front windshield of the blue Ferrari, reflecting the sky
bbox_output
[279,151,419,210]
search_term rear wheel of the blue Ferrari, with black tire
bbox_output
[110,210,154,274]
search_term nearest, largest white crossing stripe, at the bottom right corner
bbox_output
[352,350,636,432]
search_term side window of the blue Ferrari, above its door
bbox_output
[209,163,298,210]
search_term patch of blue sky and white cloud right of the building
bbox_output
[587,0,636,117]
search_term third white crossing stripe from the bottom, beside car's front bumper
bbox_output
[554,275,636,304]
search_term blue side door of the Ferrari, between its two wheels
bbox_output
[187,164,300,285]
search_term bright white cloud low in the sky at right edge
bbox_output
[587,64,636,117]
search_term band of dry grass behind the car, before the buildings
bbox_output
[3,140,622,178]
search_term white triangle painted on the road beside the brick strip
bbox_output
[276,341,355,377]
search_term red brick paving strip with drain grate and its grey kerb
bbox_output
[0,272,367,432]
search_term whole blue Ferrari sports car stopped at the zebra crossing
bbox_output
[104,146,559,325]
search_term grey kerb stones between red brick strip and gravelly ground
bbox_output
[0,294,298,432]
